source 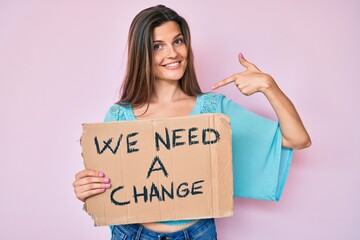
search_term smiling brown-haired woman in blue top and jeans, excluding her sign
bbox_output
[73,5,311,239]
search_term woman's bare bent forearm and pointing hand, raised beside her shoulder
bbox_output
[212,53,311,149]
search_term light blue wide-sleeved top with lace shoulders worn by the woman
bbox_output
[105,93,292,225]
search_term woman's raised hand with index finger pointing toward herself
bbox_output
[211,53,275,96]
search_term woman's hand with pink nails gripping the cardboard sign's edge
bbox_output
[73,169,111,202]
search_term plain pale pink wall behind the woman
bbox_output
[0,0,360,240]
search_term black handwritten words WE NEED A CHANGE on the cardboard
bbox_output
[94,127,220,206]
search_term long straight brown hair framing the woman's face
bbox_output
[117,5,202,107]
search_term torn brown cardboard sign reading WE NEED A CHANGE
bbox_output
[81,114,233,226]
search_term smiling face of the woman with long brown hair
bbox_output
[153,21,188,81]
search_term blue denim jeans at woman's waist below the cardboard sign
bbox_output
[111,219,216,240]
